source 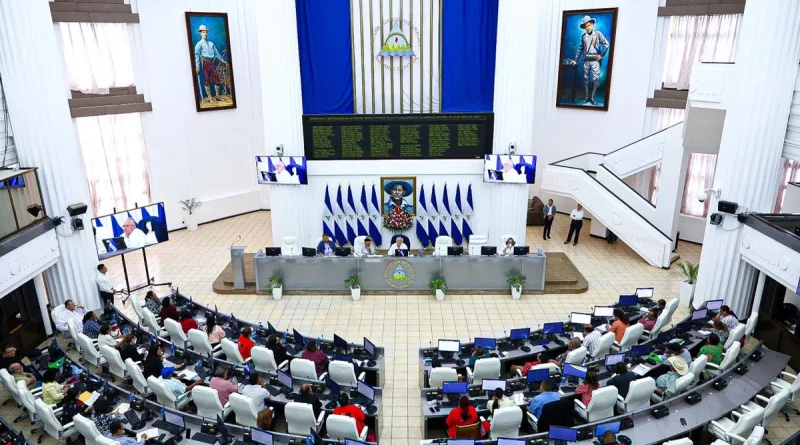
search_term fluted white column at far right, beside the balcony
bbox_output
[694,0,800,317]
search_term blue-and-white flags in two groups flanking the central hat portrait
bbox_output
[322,184,475,247]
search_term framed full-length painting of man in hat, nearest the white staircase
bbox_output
[556,8,617,111]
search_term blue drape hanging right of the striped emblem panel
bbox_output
[442,0,499,113]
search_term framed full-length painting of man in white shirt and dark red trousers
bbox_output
[186,12,236,111]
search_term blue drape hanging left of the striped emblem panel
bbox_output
[296,0,353,114]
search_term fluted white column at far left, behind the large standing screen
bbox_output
[0,0,100,308]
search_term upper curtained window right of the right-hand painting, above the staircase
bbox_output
[662,14,742,90]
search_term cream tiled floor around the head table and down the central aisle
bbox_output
[0,212,800,444]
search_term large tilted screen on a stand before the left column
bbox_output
[92,202,169,261]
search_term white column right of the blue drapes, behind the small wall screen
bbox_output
[488,0,544,245]
